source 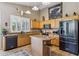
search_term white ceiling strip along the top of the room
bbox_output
[10,2,59,9]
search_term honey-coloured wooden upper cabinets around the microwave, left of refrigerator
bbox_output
[31,19,60,29]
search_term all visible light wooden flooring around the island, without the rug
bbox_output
[0,45,75,56]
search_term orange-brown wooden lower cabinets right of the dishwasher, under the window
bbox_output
[17,32,41,46]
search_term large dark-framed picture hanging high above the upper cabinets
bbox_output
[48,2,62,20]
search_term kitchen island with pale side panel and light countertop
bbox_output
[31,35,51,56]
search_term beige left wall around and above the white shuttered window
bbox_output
[0,3,39,30]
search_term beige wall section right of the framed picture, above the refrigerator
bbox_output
[63,2,79,16]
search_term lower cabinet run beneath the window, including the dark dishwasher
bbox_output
[2,32,41,50]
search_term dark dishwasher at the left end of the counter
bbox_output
[3,35,18,51]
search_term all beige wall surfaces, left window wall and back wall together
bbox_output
[0,2,79,30]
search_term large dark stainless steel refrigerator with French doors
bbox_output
[59,20,79,55]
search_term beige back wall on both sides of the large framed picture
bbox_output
[40,2,79,20]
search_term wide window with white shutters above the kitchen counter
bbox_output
[10,15,30,32]
